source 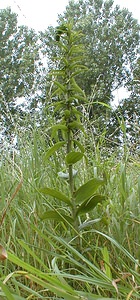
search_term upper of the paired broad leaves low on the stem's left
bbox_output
[39,188,71,205]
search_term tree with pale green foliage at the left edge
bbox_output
[0,8,40,134]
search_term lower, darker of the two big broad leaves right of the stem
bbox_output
[77,195,105,215]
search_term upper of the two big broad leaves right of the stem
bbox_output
[75,178,104,204]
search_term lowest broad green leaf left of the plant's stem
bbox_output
[40,210,73,224]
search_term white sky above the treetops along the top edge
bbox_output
[0,0,140,30]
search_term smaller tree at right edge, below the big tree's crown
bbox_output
[104,54,140,154]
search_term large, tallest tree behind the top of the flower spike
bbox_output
[42,0,140,122]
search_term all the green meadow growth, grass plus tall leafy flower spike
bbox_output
[0,24,140,300]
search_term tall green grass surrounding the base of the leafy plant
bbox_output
[0,124,140,299]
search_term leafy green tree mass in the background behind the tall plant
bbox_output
[0,0,140,149]
